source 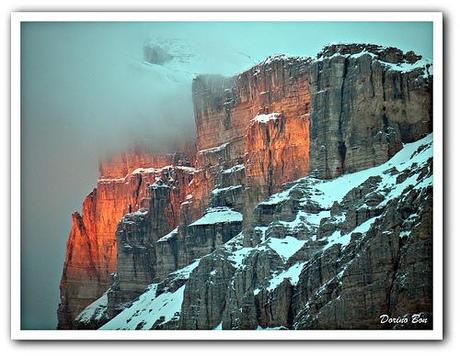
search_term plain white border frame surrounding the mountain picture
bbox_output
[11,12,443,340]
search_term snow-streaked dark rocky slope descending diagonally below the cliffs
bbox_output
[95,134,433,330]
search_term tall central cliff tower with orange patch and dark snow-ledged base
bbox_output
[100,53,309,316]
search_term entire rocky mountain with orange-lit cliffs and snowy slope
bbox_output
[58,44,433,329]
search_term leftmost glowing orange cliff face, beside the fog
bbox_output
[58,152,192,329]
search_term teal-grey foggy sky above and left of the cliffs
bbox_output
[19,22,432,329]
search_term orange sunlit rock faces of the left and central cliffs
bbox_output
[58,58,310,328]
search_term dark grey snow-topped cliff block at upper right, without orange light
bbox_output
[309,45,432,178]
